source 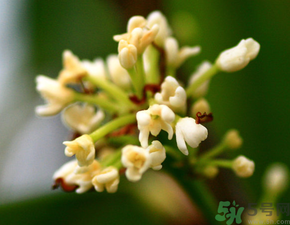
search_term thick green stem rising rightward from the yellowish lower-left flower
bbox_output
[90,114,136,142]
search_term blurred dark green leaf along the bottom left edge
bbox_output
[0,192,160,225]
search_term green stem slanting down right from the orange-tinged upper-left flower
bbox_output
[85,76,134,107]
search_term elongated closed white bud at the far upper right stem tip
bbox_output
[216,38,260,72]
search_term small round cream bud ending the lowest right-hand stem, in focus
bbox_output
[232,156,255,177]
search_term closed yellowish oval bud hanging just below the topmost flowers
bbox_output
[118,40,137,69]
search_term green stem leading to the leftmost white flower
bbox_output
[74,93,120,113]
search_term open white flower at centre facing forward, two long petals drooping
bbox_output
[136,104,175,148]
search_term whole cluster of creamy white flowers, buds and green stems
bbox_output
[36,11,260,193]
